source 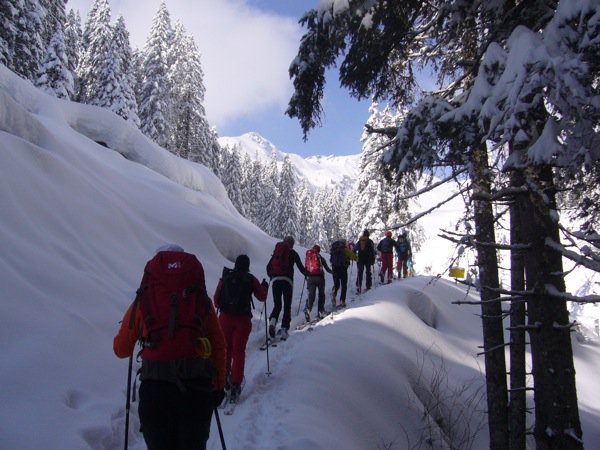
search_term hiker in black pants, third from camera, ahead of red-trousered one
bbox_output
[267,236,308,341]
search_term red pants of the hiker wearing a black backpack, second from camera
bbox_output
[219,312,252,384]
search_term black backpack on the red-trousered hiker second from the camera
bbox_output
[219,267,254,316]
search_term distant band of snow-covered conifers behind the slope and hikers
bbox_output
[0,0,420,248]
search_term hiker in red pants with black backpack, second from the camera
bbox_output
[214,255,269,403]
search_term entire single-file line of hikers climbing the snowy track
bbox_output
[113,230,411,450]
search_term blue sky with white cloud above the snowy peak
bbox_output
[67,0,369,157]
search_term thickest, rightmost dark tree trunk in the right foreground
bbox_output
[521,167,583,450]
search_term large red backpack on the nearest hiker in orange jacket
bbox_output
[137,251,216,390]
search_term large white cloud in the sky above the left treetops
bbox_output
[67,0,308,128]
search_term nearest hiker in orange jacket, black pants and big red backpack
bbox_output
[113,244,226,449]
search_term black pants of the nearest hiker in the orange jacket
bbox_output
[138,380,214,450]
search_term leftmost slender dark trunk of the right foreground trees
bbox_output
[470,144,508,450]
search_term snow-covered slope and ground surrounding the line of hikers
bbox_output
[0,66,600,450]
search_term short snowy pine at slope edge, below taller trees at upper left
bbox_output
[35,31,74,100]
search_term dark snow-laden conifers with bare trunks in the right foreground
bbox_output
[288,0,600,449]
